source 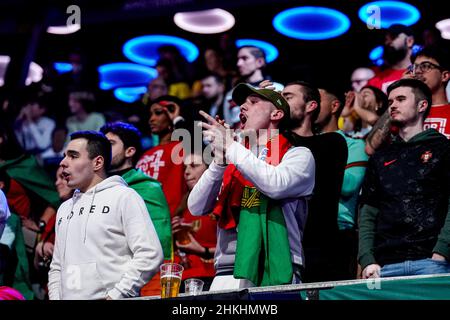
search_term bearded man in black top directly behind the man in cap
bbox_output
[282,81,348,282]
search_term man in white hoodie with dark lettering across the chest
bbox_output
[48,131,163,299]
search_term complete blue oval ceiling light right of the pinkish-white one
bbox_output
[272,7,350,40]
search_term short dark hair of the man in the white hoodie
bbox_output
[70,130,111,171]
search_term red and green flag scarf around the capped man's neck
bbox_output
[213,135,293,286]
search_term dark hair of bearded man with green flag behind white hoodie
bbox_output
[100,122,142,166]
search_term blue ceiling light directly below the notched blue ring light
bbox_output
[98,62,158,90]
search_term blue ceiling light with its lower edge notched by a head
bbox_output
[123,35,199,66]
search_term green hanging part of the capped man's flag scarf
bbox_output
[234,186,293,286]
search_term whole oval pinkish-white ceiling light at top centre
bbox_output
[173,8,235,34]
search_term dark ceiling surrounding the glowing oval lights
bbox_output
[0,0,450,97]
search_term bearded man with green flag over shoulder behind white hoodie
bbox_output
[100,122,172,260]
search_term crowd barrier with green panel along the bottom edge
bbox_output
[136,274,450,300]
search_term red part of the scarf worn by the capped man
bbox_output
[213,134,292,229]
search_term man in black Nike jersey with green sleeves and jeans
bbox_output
[359,79,450,278]
